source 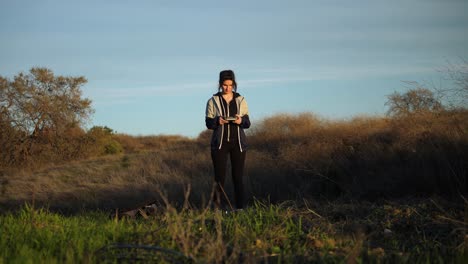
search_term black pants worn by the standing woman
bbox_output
[211,142,246,209]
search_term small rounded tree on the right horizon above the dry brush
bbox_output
[386,88,443,117]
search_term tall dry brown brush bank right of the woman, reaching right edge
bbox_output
[248,111,468,198]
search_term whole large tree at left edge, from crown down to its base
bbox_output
[0,68,93,165]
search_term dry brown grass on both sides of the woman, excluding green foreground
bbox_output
[0,111,468,210]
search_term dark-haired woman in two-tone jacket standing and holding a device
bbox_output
[205,70,250,209]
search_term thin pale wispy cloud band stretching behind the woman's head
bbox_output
[91,65,435,105]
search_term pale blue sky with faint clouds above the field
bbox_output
[0,0,468,137]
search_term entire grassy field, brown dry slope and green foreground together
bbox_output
[0,111,468,263]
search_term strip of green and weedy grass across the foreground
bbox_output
[0,199,468,263]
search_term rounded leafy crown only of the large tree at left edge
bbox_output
[0,68,92,136]
